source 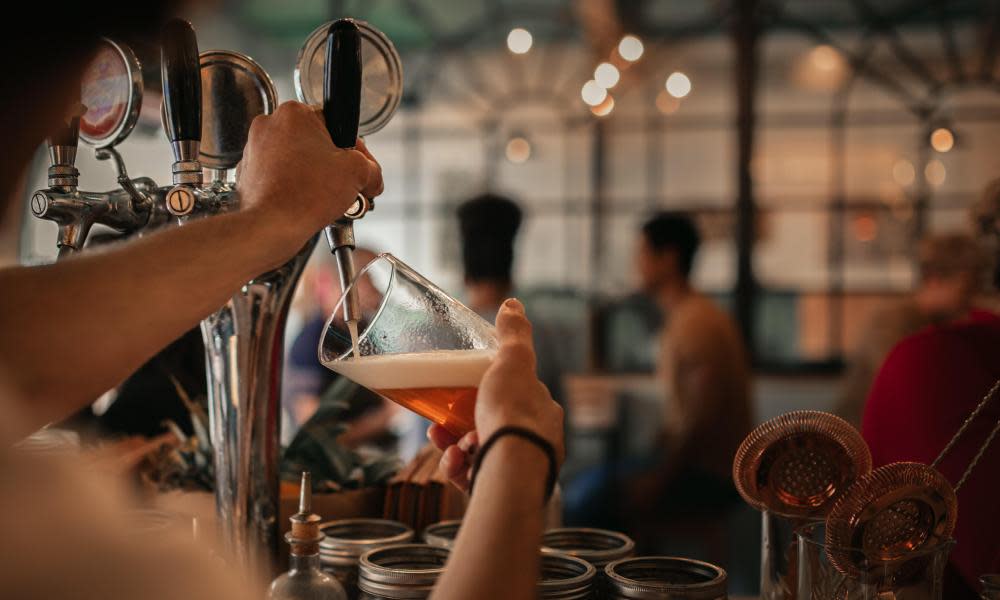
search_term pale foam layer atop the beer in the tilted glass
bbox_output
[323,350,495,390]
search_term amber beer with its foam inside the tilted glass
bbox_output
[324,350,494,435]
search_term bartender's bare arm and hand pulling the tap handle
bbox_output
[0,102,382,433]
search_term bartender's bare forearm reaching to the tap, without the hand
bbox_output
[0,211,304,433]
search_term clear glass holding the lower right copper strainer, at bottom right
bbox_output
[797,521,955,600]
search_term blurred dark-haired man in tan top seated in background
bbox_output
[632,212,751,514]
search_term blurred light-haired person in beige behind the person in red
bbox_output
[834,233,989,427]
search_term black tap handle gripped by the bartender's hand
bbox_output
[323,19,361,148]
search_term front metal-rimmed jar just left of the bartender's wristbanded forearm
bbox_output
[358,544,449,600]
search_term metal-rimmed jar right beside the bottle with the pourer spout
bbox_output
[319,519,413,598]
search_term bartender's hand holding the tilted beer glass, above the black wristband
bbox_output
[427,299,565,490]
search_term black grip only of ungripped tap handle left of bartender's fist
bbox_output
[160,19,201,142]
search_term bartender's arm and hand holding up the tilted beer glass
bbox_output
[430,300,563,600]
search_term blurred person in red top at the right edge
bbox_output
[861,311,1000,600]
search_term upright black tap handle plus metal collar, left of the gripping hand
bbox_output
[160,19,202,216]
